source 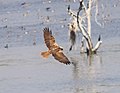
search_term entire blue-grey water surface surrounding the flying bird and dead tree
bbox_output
[0,0,120,93]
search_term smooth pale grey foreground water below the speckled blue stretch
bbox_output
[0,46,120,93]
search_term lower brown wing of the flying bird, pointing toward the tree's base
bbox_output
[52,50,70,65]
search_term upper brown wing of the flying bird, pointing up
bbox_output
[43,28,55,49]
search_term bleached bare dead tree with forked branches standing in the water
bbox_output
[68,0,102,55]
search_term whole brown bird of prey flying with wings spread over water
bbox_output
[41,28,70,64]
